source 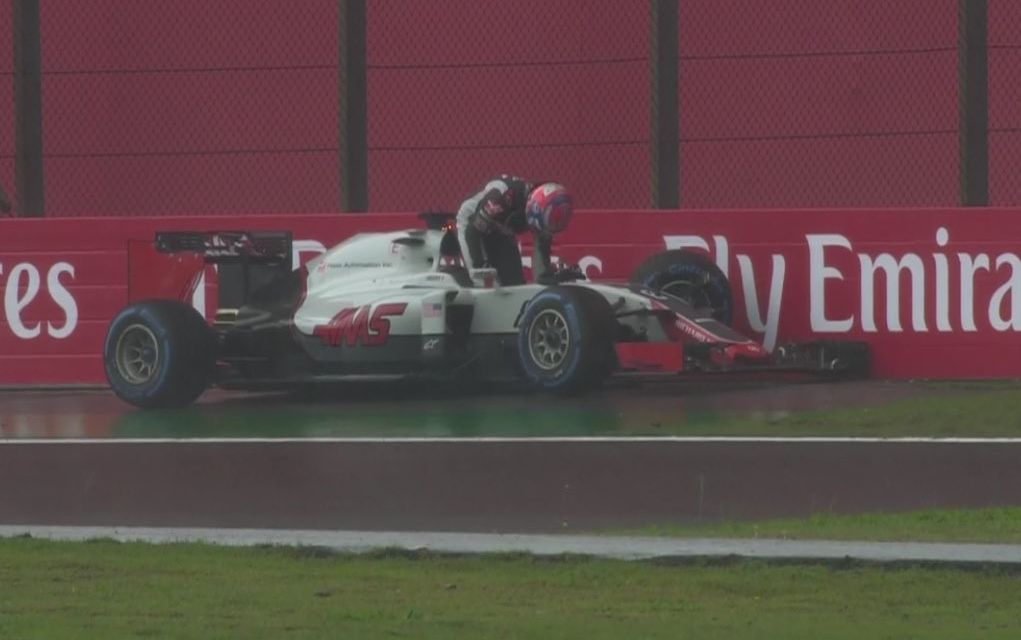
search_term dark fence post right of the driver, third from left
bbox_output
[649,0,681,209]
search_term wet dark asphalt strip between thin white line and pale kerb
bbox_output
[0,441,1021,532]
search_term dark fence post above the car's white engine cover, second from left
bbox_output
[338,0,369,211]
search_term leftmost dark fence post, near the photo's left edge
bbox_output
[12,0,45,217]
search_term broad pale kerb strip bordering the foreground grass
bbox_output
[0,525,1021,564]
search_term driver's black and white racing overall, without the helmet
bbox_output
[457,176,552,285]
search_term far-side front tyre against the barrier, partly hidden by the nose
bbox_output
[631,249,734,326]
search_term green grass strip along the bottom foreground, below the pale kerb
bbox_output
[0,539,1021,640]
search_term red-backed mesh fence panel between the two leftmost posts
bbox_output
[17,0,338,215]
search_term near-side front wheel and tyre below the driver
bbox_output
[518,287,617,394]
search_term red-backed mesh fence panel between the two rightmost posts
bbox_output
[680,0,958,207]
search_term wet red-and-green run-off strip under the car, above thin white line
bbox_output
[0,382,934,439]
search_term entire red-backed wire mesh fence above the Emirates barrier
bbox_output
[0,0,1021,215]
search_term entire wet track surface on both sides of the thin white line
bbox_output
[0,383,1021,532]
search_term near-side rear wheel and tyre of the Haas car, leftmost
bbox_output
[103,300,215,409]
